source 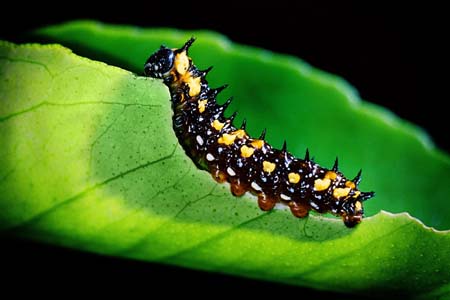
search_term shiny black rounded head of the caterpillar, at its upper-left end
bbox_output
[144,46,175,78]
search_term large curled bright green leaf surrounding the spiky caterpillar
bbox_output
[0,22,450,297]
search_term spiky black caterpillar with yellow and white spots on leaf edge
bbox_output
[144,38,374,228]
